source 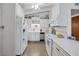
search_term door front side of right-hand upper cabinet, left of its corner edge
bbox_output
[49,4,60,26]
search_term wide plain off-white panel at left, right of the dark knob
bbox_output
[2,3,16,56]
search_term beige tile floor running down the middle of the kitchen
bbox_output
[23,41,47,56]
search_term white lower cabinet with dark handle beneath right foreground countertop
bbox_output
[52,42,70,56]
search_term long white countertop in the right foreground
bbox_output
[50,34,79,56]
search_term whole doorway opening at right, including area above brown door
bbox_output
[71,9,79,41]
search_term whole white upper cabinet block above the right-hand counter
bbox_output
[50,4,67,26]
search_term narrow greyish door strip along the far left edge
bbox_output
[0,4,3,56]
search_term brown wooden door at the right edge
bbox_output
[72,16,79,41]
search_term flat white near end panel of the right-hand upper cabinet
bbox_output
[57,4,69,26]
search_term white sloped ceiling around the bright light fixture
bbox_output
[19,3,55,14]
